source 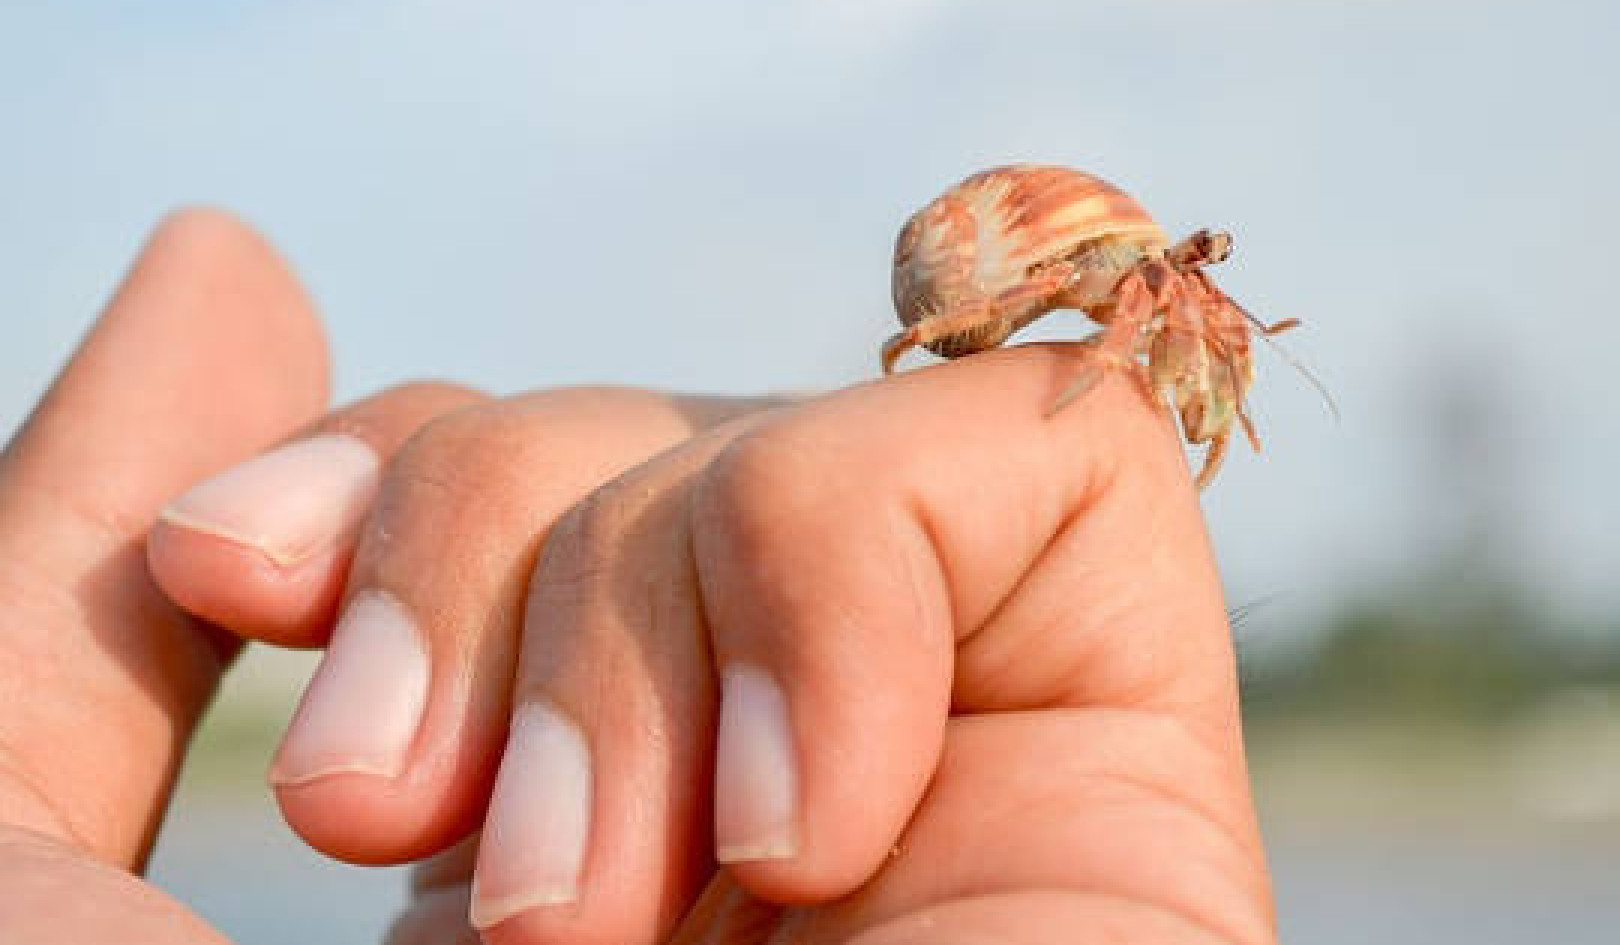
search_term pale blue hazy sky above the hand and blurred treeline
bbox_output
[0,0,1620,635]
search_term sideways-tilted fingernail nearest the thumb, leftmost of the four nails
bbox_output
[160,433,379,567]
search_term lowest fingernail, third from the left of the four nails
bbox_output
[470,702,591,929]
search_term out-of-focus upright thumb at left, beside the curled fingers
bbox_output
[0,211,327,866]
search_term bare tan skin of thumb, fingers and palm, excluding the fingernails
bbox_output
[0,212,1275,945]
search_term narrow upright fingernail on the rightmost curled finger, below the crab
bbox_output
[714,665,799,862]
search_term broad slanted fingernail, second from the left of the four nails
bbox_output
[271,590,428,786]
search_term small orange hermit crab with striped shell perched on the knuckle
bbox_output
[883,164,1299,490]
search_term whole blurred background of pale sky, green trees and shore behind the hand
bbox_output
[0,0,1620,945]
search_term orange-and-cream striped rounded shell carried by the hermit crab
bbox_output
[893,164,1168,357]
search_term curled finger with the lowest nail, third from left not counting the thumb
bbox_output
[471,417,757,945]
